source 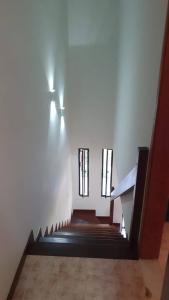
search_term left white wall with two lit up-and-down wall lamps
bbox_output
[0,0,72,300]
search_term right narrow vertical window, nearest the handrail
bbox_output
[101,149,113,197]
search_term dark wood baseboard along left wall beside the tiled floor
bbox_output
[7,231,34,300]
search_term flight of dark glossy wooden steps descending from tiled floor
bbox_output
[27,223,137,259]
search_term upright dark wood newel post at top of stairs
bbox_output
[130,147,149,246]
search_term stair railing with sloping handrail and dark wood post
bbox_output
[110,147,149,247]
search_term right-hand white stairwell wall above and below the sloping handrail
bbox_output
[113,0,167,231]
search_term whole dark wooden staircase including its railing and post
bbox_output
[26,147,149,259]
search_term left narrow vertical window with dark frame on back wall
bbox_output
[78,148,89,197]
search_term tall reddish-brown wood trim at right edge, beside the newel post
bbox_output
[139,2,169,259]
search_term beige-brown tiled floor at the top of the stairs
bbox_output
[13,224,169,300]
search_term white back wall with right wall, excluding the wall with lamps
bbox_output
[68,0,167,232]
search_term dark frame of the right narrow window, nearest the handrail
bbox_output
[101,148,113,198]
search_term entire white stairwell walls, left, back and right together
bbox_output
[0,0,167,300]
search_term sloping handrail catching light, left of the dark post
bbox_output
[111,166,137,200]
